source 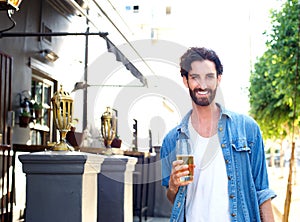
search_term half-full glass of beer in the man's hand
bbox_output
[176,138,194,182]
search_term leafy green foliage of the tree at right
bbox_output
[249,0,300,138]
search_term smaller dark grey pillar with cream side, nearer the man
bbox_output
[97,155,137,222]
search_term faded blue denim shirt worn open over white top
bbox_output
[160,105,276,222]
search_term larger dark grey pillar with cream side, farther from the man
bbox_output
[19,151,104,222]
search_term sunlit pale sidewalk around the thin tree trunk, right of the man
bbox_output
[268,166,300,222]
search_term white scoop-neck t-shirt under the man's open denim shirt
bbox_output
[185,118,230,222]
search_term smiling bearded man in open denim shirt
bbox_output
[161,48,276,222]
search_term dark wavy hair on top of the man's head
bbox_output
[180,47,223,78]
